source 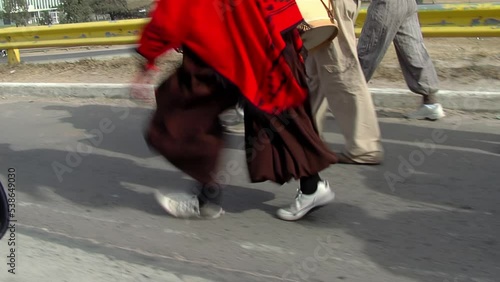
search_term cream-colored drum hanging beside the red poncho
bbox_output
[296,0,339,51]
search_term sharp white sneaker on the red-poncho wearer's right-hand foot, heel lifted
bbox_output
[277,180,335,220]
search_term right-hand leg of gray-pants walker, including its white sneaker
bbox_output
[394,2,444,120]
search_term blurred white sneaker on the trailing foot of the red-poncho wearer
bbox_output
[155,191,224,219]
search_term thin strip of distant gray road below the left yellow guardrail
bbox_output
[0,47,134,65]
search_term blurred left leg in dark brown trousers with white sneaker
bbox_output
[146,49,237,217]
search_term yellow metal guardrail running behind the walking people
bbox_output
[0,2,500,65]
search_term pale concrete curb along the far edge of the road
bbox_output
[0,83,500,112]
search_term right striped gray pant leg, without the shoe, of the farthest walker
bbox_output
[394,2,439,95]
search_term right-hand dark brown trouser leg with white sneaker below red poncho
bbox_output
[245,98,337,220]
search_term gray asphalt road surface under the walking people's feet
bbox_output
[0,98,500,282]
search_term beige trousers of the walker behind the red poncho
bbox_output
[305,0,383,163]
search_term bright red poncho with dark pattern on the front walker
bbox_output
[138,0,307,114]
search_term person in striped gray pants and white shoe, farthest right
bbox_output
[358,0,445,120]
